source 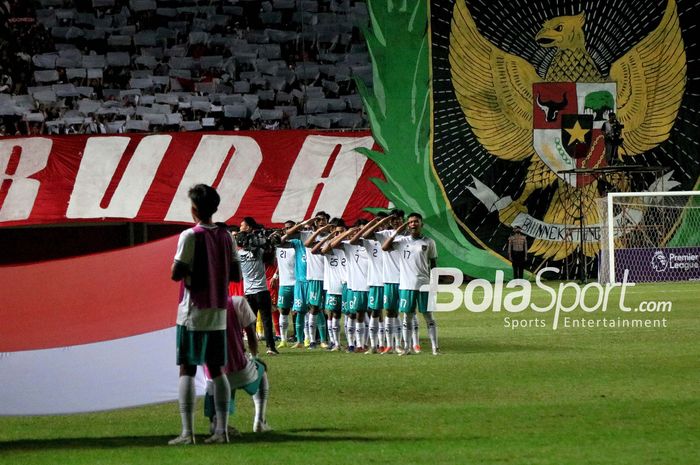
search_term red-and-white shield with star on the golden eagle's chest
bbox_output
[532,82,616,187]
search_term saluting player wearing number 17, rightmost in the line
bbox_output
[382,212,439,355]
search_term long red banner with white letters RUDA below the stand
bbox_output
[0,131,387,226]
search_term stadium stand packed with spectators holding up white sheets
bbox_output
[0,0,372,136]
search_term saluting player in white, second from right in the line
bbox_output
[363,210,404,354]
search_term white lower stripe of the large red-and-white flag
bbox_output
[0,327,206,415]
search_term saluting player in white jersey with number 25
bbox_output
[313,218,356,352]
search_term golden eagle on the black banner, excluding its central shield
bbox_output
[449,0,686,260]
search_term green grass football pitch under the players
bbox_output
[0,283,700,465]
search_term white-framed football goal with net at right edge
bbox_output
[598,191,700,283]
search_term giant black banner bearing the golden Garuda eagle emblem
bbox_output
[429,0,700,270]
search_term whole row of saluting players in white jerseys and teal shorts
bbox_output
[266,210,440,355]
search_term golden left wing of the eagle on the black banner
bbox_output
[449,0,542,161]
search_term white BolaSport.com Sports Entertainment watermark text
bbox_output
[421,267,673,330]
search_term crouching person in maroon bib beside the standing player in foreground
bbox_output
[204,296,271,442]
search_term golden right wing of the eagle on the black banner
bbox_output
[610,0,686,155]
